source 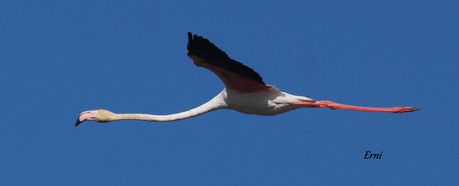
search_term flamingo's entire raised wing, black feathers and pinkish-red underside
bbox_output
[187,32,271,92]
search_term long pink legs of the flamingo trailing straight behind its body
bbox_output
[293,101,419,114]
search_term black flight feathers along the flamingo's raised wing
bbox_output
[187,32,265,84]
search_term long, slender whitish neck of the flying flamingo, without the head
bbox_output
[110,93,227,122]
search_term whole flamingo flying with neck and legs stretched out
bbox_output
[75,32,420,127]
